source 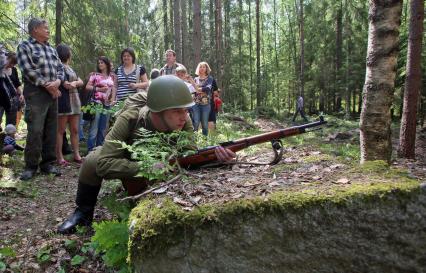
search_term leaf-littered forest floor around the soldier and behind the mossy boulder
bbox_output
[0,115,426,273]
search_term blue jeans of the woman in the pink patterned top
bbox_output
[87,106,109,152]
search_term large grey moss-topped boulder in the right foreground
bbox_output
[129,180,426,273]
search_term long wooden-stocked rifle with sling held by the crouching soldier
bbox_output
[177,116,327,168]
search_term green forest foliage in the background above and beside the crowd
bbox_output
[0,0,426,116]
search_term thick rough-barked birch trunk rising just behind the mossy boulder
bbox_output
[360,0,402,163]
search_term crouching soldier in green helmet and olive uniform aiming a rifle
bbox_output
[58,75,235,234]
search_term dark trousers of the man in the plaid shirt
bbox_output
[24,82,58,169]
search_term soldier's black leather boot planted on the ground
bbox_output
[58,182,101,234]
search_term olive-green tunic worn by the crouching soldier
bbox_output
[96,93,194,179]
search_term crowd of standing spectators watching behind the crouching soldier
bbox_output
[0,18,222,180]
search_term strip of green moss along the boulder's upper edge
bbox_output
[129,178,419,259]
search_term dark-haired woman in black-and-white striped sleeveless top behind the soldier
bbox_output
[116,48,148,101]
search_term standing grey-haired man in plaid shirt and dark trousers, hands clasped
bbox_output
[17,18,64,180]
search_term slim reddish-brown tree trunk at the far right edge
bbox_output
[398,0,424,159]
